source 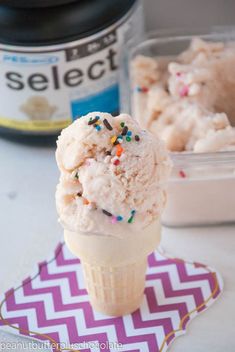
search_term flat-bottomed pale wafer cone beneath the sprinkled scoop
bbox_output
[65,221,160,316]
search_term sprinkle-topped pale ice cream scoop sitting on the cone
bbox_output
[56,112,171,236]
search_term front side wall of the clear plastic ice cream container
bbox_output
[162,152,235,226]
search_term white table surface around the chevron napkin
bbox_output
[0,139,235,352]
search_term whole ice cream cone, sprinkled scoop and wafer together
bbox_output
[56,112,171,316]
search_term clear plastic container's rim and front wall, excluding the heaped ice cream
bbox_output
[121,27,235,227]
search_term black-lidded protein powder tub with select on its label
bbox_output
[0,0,143,135]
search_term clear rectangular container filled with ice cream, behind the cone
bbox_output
[121,27,235,226]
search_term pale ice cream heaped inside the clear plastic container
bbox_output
[131,38,235,152]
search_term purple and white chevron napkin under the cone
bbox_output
[0,243,223,352]
